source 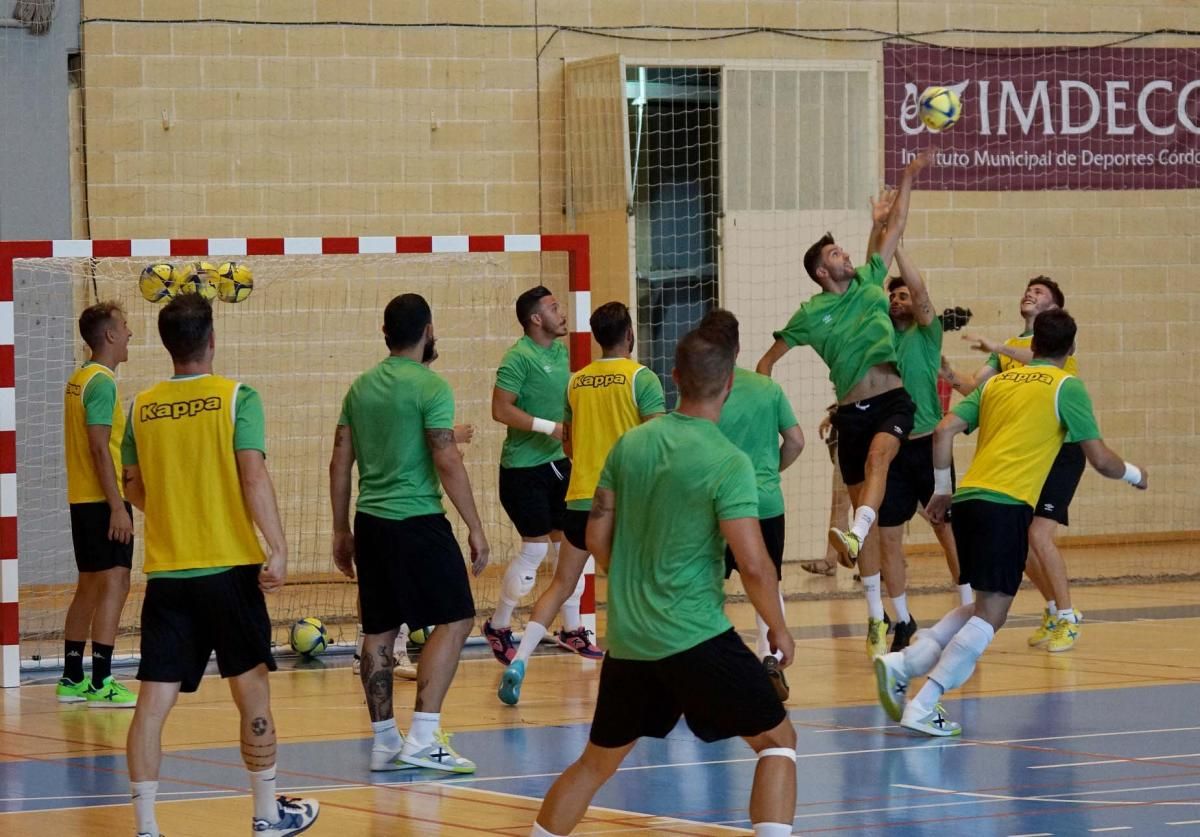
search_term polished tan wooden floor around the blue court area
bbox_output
[0,556,1200,837]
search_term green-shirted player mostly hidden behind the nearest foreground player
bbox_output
[698,308,804,700]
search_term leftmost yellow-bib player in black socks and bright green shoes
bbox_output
[55,302,137,709]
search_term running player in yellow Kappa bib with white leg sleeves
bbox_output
[875,307,1146,736]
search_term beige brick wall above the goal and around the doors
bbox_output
[83,0,1200,554]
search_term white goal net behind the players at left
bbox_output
[5,237,588,667]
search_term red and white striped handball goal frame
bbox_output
[0,235,595,687]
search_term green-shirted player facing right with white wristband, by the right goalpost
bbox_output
[482,285,583,668]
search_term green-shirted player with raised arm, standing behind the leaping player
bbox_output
[864,247,971,658]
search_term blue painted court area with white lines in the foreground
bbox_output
[0,676,1200,837]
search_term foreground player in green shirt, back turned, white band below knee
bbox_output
[532,331,796,837]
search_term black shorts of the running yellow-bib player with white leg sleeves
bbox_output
[950,500,1033,596]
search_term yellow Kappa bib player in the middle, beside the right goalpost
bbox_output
[497,302,666,706]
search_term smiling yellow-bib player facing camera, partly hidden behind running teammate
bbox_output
[950,276,1085,651]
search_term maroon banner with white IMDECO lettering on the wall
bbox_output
[883,44,1200,191]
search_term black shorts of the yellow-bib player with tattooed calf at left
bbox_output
[138,564,275,692]
